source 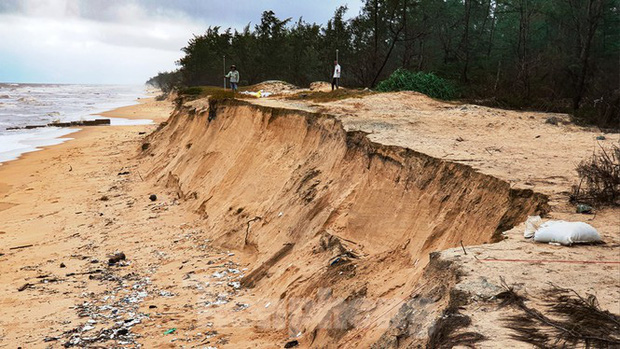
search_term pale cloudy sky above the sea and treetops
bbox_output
[0,0,362,84]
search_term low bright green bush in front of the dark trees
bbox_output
[377,69,457,100]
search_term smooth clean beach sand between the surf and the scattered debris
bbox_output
[0,98,177,348]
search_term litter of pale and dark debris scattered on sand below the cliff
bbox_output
[37,228,251,348]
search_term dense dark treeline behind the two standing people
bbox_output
[151,0,620,127]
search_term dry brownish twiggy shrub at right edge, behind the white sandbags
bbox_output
[571,145,620,205]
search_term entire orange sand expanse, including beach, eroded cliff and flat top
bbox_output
[0,93,620,348]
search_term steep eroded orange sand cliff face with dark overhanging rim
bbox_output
[142,100,547,346]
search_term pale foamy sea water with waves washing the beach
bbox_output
[0,83,152,165]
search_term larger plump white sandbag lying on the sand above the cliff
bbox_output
[534,221,601,246]
